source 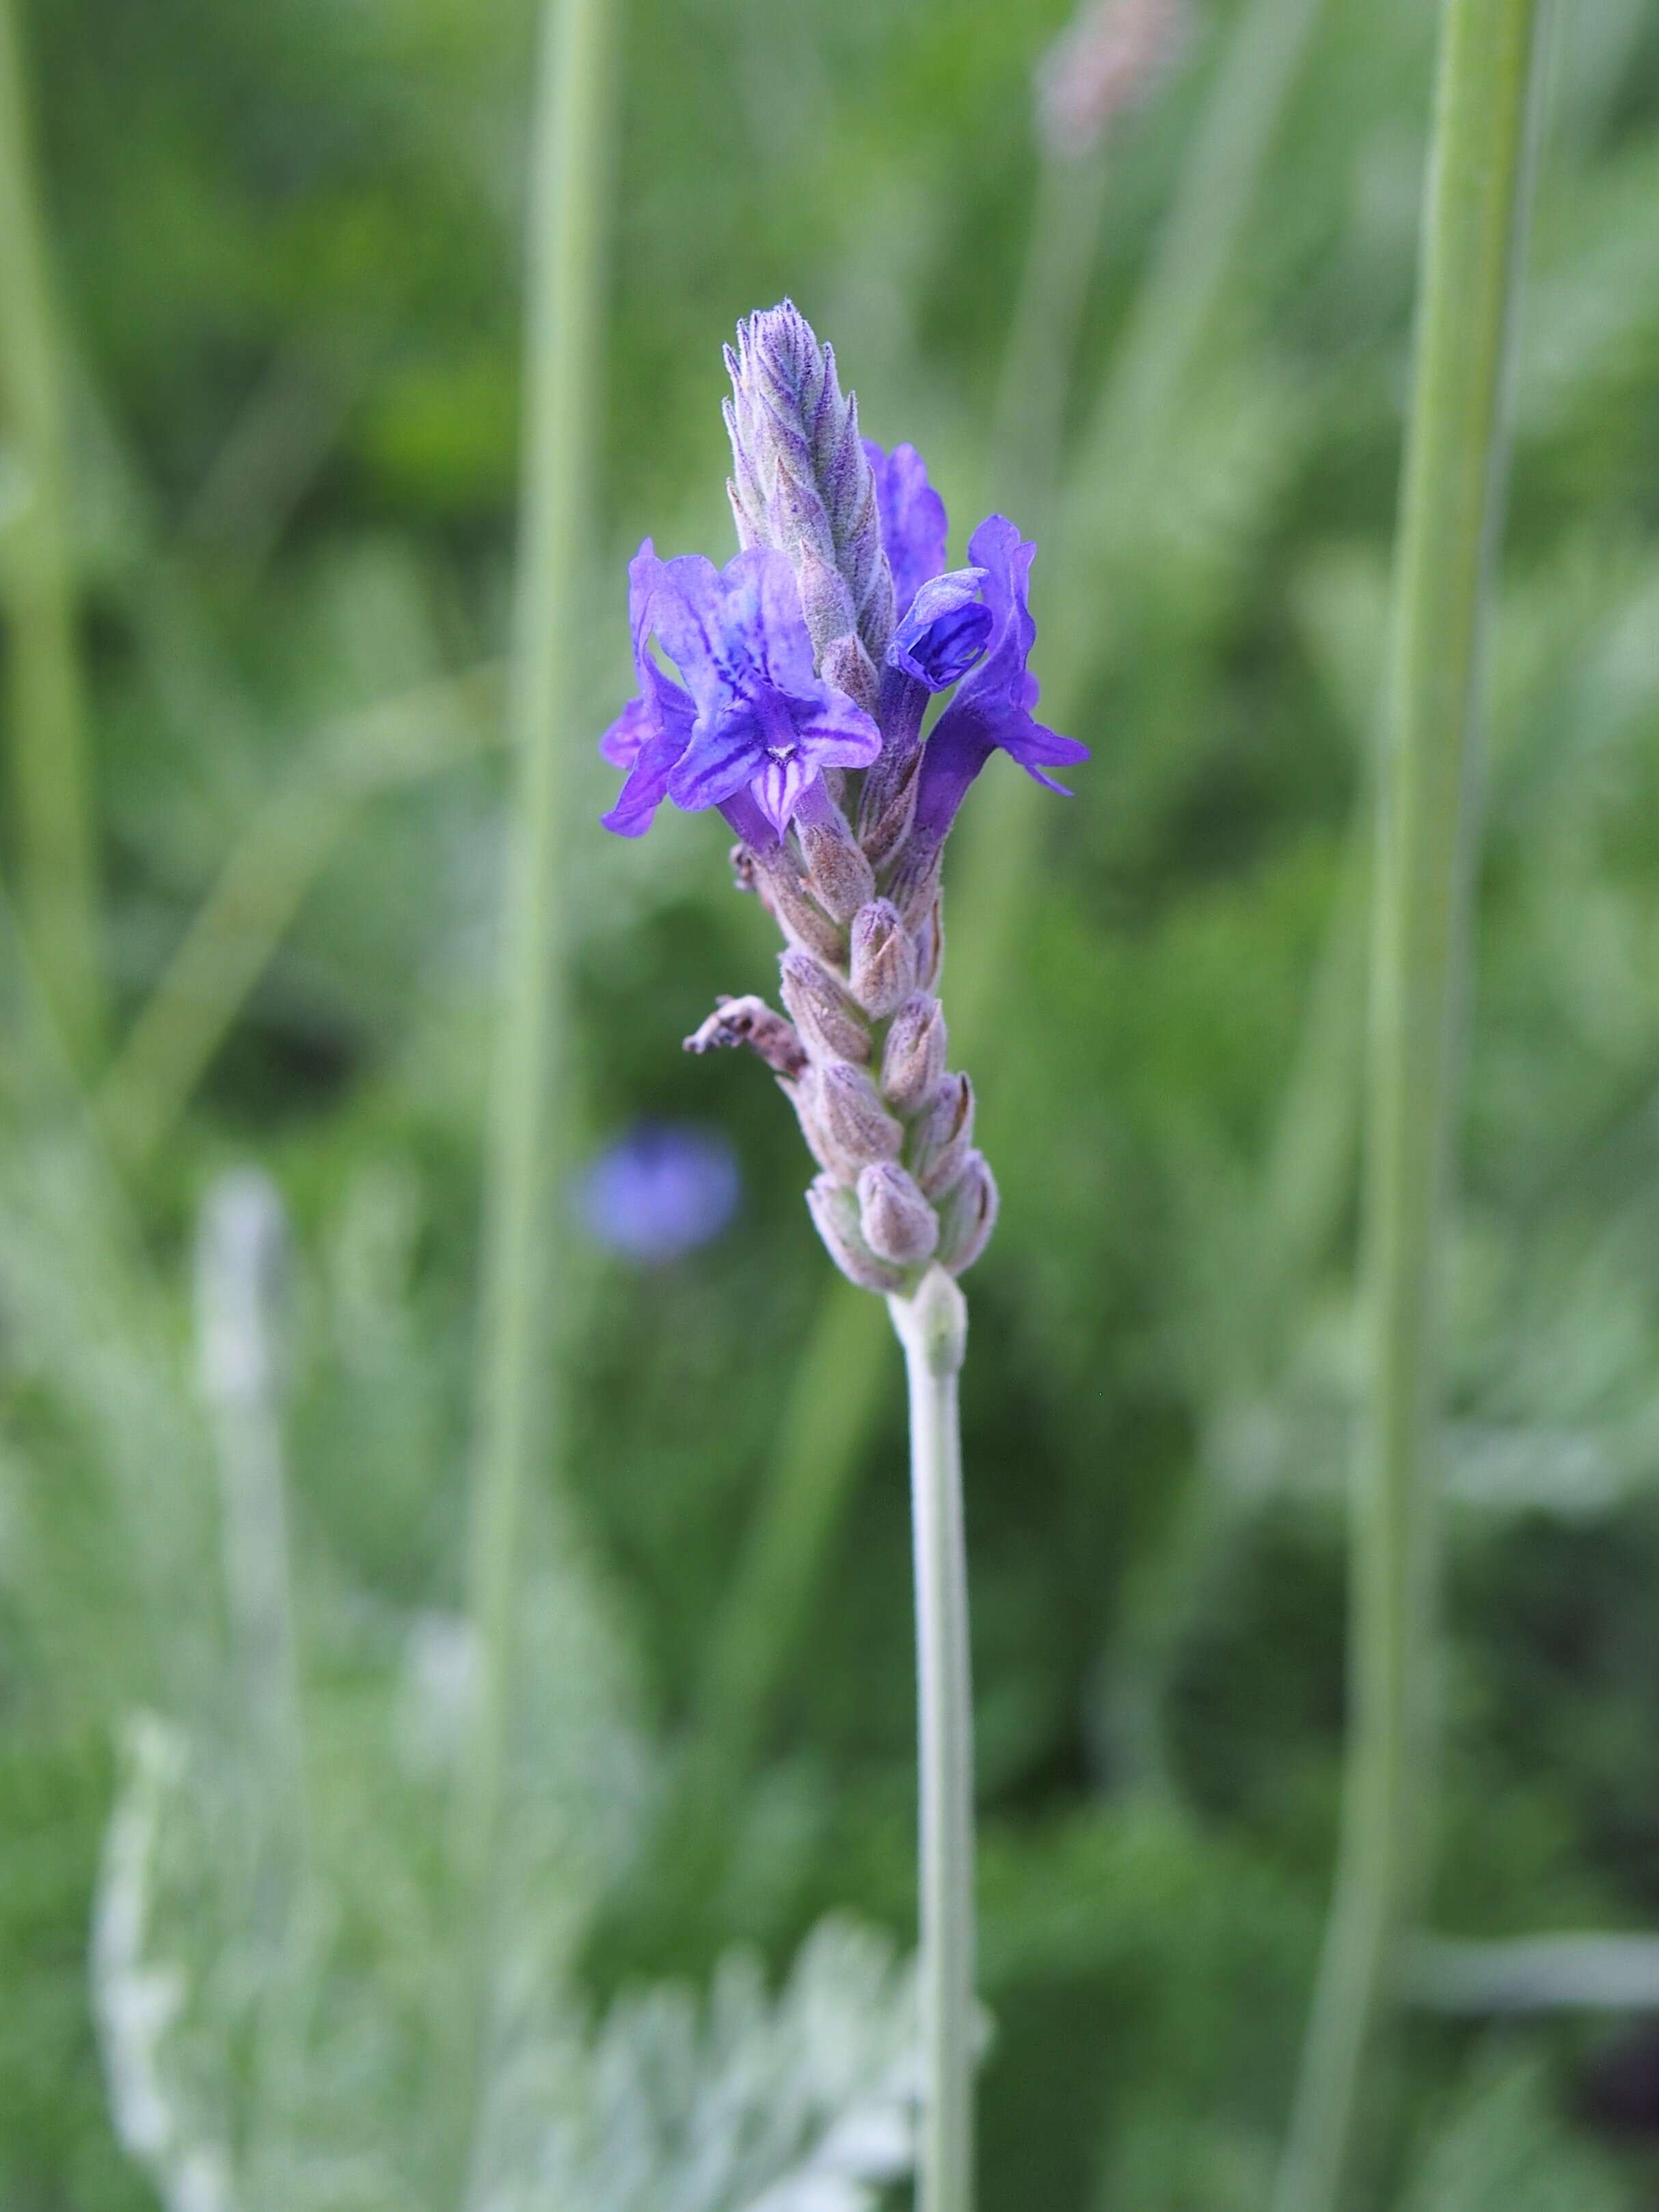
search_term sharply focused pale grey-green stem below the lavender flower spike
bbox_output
[887,1267,973,2212]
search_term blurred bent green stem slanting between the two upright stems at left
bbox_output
[97,671,496,1170]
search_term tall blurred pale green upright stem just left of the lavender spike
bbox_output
[442,0,617,2201]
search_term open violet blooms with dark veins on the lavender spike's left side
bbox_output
[599,540,880,836]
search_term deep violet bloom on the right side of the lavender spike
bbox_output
[916,515,1088,843]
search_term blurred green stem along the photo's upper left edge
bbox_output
[0,0,102,1068]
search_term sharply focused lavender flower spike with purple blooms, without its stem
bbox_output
[602,301,1088,1292]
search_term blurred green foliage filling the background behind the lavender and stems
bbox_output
[0,0,1659,2212]
